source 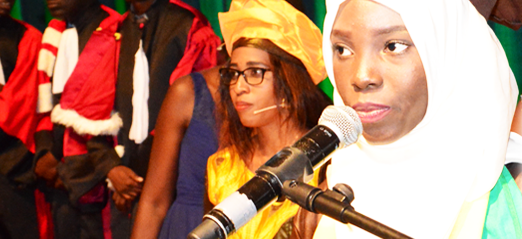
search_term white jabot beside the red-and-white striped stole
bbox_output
[52,27,79,94]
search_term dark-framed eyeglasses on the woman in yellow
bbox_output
[219,67,270,85]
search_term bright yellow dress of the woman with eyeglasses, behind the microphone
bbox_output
[207,148,317,239]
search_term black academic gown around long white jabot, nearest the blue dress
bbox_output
[115,0,194,177]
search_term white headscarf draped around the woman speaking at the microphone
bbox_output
[323,0,518,238]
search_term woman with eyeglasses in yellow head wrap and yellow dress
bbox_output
[203,0,330,239]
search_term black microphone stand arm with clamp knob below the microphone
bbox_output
[283,180,411,239]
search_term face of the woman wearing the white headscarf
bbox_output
[330,0,428,144]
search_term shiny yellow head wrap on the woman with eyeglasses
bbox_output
[218,0,326,84]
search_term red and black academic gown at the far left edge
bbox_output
[0,19,42,238]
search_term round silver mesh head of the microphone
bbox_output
[319,105,363,149]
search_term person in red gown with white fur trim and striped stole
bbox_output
[35,0,122,238]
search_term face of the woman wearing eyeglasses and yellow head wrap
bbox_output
[229,47,279,128]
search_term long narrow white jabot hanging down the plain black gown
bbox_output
[129,40,149,144]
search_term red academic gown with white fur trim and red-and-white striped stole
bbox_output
[35,6,122,239]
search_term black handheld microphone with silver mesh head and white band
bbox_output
[187,106,362,239]
